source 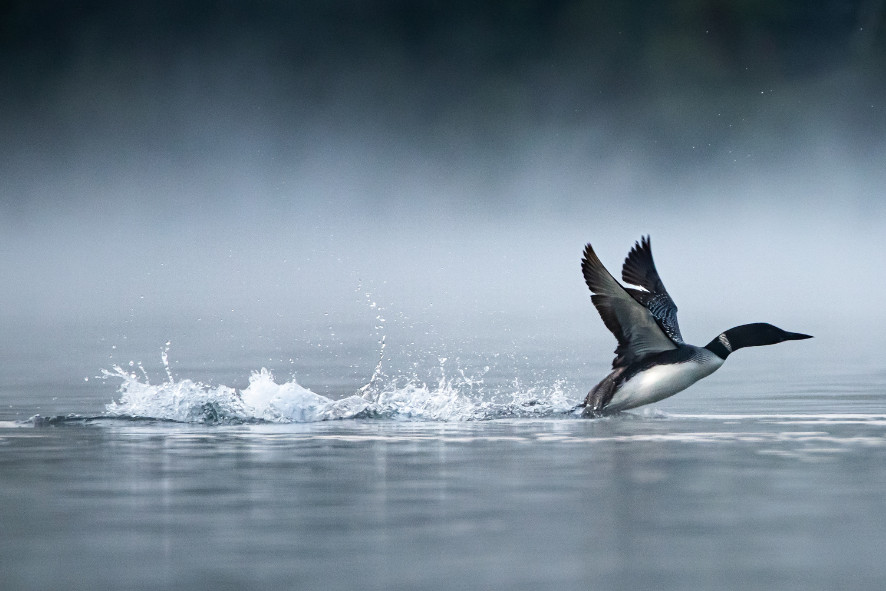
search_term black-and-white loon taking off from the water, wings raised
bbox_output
[577,236,812,417]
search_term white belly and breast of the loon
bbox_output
[606,356,723,411]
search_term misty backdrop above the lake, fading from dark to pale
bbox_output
[0,1,886,360]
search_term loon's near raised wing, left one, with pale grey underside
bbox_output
[581,244,677,368]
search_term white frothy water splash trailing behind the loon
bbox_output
[102,350,574,424]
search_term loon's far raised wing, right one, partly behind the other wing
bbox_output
[621,236,683,344]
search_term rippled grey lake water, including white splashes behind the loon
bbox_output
[0,327,886,590]
